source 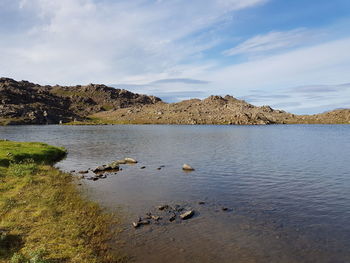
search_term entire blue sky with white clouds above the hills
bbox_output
[0,0,350,114]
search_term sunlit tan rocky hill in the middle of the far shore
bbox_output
[92,95,295,125]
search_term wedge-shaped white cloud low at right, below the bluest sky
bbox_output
[193,38,350,112]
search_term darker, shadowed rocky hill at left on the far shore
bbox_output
[0,78,160,124]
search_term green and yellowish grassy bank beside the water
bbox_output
[0,141,123,263]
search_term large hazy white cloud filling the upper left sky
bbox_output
[0,0,265,84]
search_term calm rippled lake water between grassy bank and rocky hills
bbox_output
[0,125,350,262]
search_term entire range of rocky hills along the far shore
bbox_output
[0,78,350,125]
